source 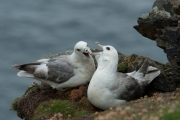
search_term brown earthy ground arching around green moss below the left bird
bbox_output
[17,85,98,120]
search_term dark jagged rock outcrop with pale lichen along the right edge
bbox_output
[134,0,180,86]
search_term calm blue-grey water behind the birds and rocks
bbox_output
[0,0,167,120]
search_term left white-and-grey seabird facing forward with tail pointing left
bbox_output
[12,41,95,91]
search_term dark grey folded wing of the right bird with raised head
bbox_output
[117,73,143,101]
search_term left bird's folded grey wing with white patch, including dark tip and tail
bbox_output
[12,55,76,83]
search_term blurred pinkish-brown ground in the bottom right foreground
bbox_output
[95,90,180,120]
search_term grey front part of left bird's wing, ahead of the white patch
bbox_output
[47,56,76,83]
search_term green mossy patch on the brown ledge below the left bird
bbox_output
[34,100,88,119]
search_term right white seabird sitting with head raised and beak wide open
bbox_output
[87,43,160,110]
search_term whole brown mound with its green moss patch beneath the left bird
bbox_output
[13,84,98,120]
